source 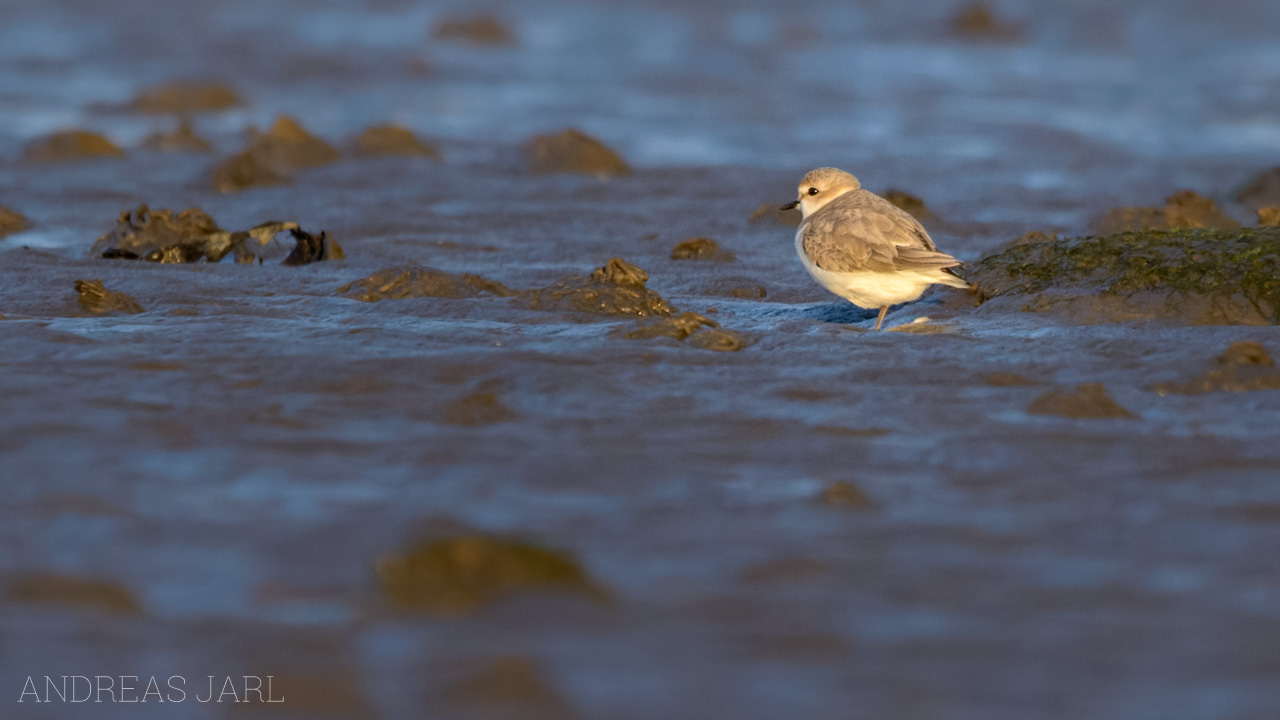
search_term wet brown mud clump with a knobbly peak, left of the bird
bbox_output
[522,258,672,318]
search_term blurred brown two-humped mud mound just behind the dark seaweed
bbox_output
[212,115,339,192]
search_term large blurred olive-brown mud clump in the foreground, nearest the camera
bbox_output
[378,534,607,616]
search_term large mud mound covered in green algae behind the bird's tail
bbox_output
[968,228,1280,325]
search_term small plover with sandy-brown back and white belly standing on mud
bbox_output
[782,168,969,331]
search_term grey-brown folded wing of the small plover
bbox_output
[800,193,960,273]
